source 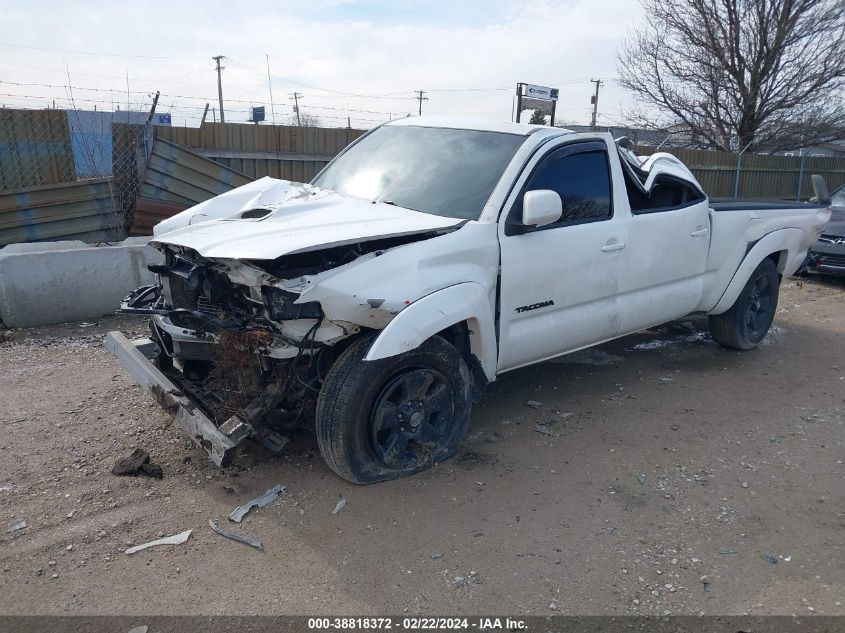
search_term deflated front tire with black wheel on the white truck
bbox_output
[316,335,472,484]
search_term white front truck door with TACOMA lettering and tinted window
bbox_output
[498,141,630,371]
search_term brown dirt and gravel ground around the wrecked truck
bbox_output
[0,280,845,615]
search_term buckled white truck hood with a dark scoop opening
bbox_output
[151,178,465,259]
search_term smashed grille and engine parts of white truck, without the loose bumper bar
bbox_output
[113,248,360,461]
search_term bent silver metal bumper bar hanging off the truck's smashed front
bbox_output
[104,332,239,466]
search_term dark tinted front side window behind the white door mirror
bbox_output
[508,146,612,228]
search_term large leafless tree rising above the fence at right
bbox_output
[618,0,845,151]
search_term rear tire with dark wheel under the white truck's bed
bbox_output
[709,257,780,350]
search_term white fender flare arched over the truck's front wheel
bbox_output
[364,282,498,381]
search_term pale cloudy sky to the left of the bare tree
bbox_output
[0,0,643,128]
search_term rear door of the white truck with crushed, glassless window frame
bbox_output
[620,176,710,334]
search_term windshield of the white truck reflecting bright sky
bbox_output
[313,126,525,220]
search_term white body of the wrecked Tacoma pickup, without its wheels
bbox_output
[112,117,830,478]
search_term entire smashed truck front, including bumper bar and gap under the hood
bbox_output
[108,225,458,464]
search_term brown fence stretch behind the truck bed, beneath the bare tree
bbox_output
[634,147,845,200]
